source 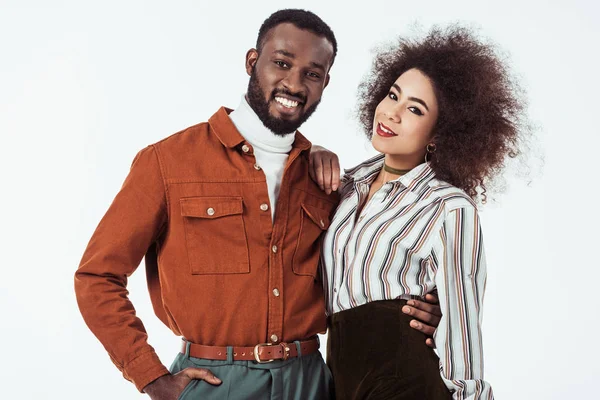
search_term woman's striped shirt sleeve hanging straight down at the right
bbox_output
[432,205,493,400]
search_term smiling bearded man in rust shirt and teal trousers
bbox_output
[75,10,436,400]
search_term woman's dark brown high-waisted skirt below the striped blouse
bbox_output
[327,300,452,400]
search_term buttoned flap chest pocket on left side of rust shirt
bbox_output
[180,197,250,275]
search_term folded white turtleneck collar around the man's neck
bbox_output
[229,96,295,154]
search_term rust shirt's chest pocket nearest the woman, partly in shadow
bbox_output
[292,203,329,278]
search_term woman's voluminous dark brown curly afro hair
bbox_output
[358,25,527,202]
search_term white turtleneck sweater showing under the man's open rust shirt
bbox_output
[229,96,295,219]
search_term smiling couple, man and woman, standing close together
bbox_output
[75,10,518,400]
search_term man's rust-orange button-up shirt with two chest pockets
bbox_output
[75,108,338,390]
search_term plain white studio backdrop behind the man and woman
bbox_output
[0,0,600,400]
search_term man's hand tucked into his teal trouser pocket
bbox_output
[144,368,221,400]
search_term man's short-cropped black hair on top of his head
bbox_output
[256,8,337,65]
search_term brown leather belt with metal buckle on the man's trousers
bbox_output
[181,337,319,364]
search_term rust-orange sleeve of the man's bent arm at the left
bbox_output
[75,147,168,390]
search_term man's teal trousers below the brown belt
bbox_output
[170,342,335,400]
